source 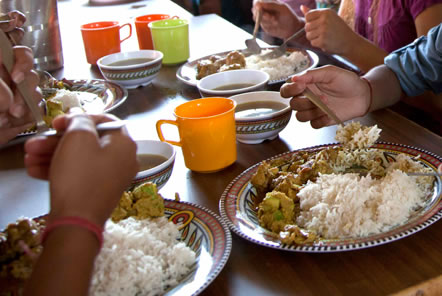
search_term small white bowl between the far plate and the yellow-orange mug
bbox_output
[197,69,270,97]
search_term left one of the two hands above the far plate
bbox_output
[252,1,304,39]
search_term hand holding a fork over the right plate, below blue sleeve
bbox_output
[280,66,371,128]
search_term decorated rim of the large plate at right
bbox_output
[219,142,442,253]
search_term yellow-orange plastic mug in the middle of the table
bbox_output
[156,98,236,173]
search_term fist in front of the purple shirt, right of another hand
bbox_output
[301,5,357,55]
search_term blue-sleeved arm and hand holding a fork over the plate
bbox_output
[280,24,442,128]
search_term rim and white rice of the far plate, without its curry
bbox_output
[176,47,319,86]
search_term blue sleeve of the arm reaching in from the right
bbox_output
[384,24,442,96]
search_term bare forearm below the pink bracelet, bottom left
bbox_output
[25,225,99,296]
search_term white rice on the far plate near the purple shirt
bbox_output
[246,50,309,80]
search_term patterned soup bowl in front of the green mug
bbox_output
[97,50,163,89]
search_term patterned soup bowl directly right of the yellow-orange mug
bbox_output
[230,91,292,144]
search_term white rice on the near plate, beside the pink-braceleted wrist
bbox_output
[90,217,195,296]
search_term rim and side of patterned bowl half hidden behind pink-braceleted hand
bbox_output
[132,140,176,189]
